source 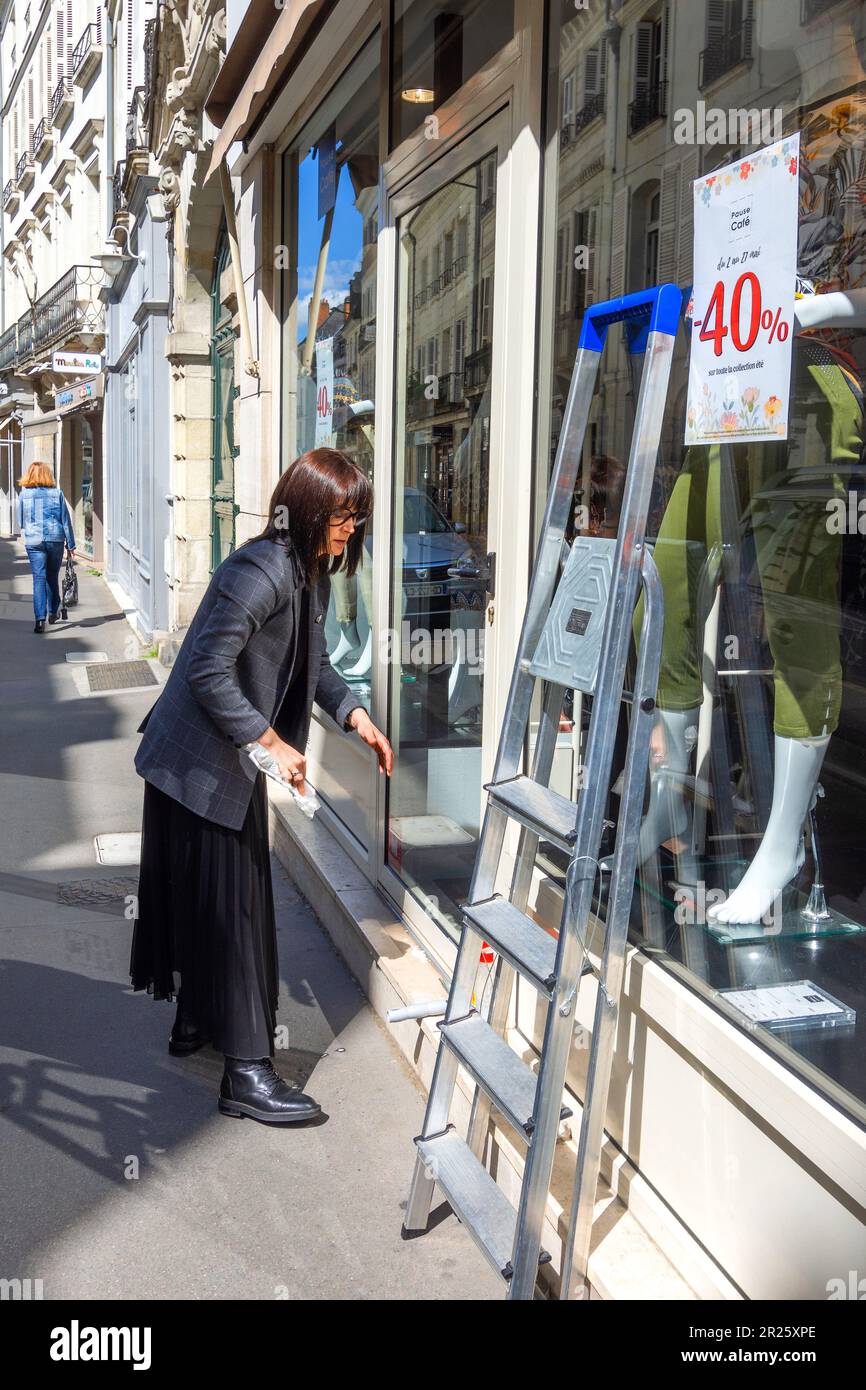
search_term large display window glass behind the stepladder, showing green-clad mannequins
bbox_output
[538,0,866,1120]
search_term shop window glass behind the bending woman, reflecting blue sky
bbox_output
[284,33,379,709]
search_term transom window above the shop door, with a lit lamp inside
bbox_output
[391,0,514,149]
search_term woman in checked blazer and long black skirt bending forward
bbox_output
[129,449,393,1125]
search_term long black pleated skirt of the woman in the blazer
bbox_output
[129,773,279,1058]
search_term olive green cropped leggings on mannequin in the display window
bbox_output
[635,347,863,738]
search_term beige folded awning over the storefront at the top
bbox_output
[204,0,331,182]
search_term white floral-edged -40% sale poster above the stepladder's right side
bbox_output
[685,133,799,445]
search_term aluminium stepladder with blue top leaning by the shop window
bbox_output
[403,285,683,1300]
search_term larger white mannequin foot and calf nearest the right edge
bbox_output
[706,734,830,923]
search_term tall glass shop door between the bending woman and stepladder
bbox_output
[385,121,506,938]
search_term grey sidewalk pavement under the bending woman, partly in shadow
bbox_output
[0,539,503,1300]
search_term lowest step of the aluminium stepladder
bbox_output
[416,1126,550,1279]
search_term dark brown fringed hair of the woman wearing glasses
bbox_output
[253,449,373,584]
